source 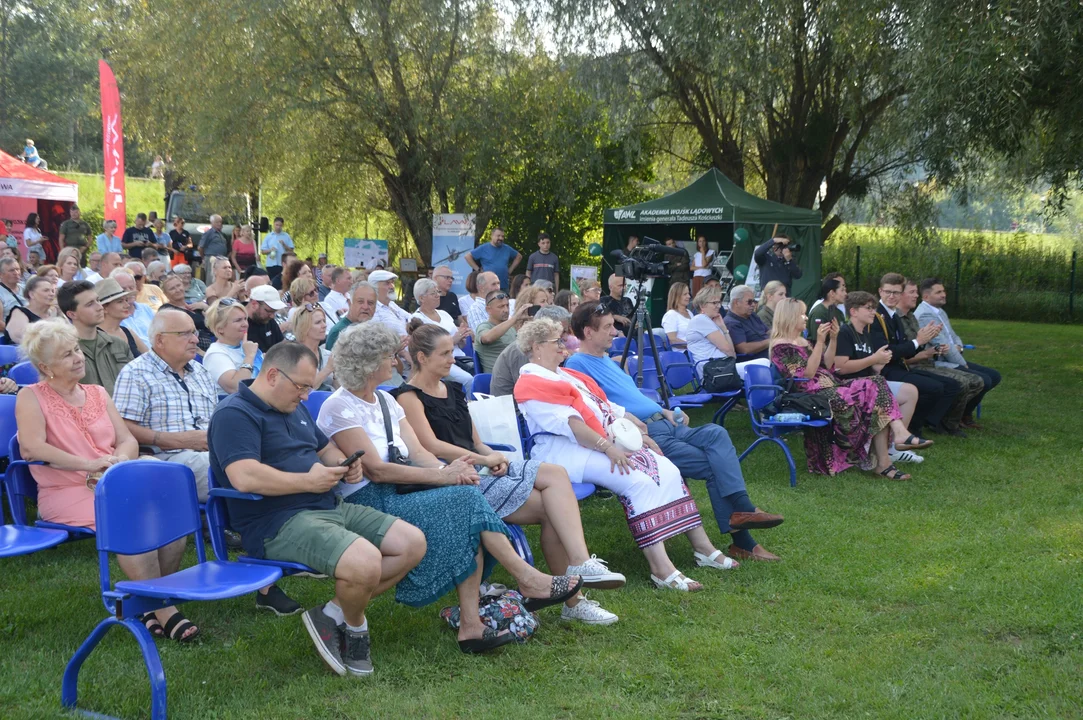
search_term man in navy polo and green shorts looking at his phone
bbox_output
[207,342,426,676]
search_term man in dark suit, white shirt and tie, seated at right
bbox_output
[869,273,961,434]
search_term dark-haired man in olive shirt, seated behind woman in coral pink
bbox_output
[56,280,134,395]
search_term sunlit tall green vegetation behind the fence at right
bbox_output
[823,225,1083,323]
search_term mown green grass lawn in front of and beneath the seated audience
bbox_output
[0,320,1083,720]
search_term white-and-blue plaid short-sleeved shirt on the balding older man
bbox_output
[113,350,218,451]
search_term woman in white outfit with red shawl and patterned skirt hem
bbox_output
[514,319,738,592]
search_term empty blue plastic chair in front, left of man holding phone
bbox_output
[61,460,282,720]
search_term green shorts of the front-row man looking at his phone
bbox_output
[263,502,399,577]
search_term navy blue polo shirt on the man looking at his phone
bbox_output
[207,380,336,558]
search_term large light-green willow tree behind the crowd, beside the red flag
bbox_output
[107,0,643,258]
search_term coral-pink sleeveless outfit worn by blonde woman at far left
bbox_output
[30,382,117,529]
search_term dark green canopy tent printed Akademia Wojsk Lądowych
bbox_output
[602,168,822,322]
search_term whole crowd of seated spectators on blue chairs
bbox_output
[0,238,1001,676]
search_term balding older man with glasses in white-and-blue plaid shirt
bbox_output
[113,309,218,502]
